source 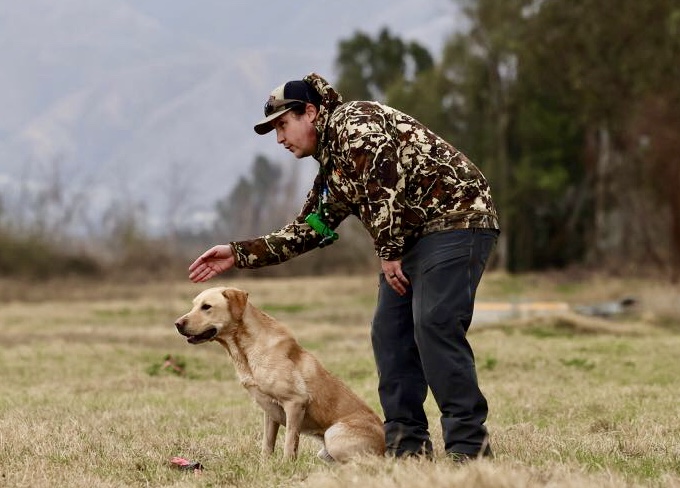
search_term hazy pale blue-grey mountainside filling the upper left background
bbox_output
[0,0,457,234]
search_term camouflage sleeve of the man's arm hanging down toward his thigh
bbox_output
[349,121,406,260]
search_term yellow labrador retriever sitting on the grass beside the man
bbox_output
[175,287,385,462]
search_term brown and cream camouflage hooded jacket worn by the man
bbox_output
[230,73,499,268]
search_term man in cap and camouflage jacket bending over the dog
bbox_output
[189,73,499,460]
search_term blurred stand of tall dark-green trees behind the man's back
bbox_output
[337,0,680,276]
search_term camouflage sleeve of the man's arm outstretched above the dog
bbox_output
[229,176,350,268]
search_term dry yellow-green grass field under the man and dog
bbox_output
[0,273,680,488]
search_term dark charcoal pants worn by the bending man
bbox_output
[371,229,498,456]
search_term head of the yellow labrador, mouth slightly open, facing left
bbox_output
[175,287,248,344]
